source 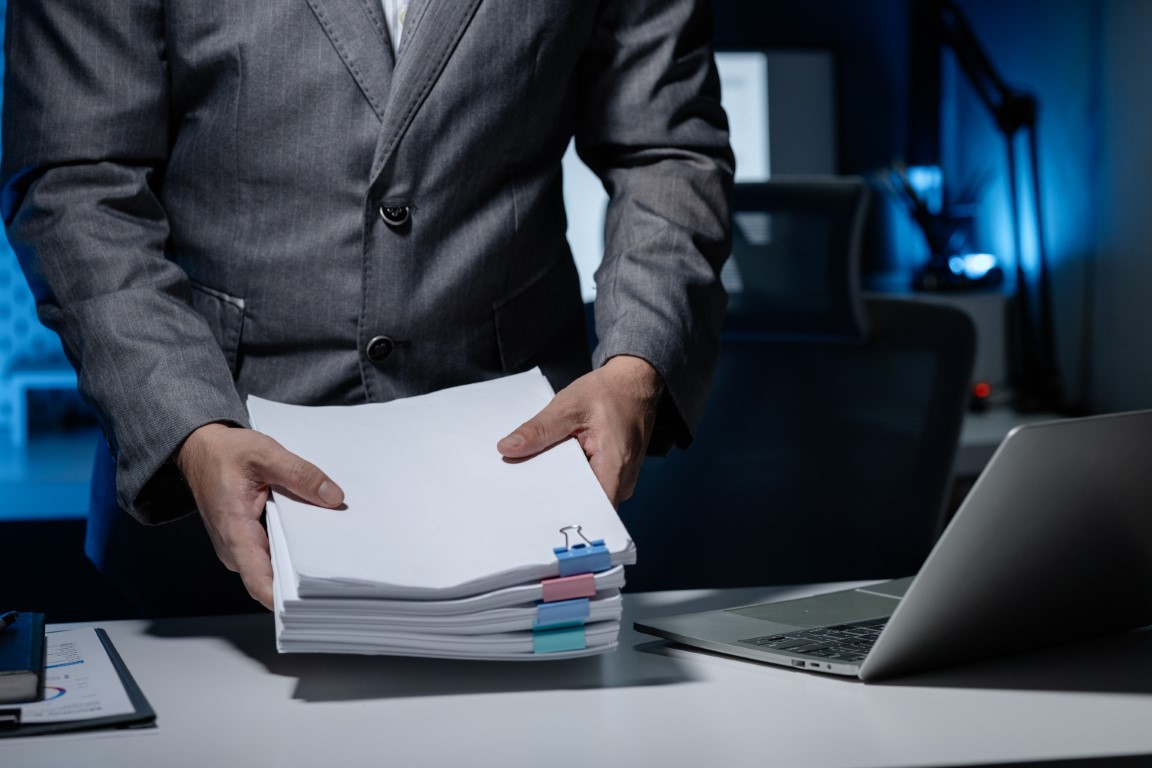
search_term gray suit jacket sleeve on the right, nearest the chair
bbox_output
[576,0,734,453]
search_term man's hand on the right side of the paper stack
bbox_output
[497,356,664,505]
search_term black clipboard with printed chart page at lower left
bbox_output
[0,628,156,736]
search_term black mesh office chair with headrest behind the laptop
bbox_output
[621,178,976,591]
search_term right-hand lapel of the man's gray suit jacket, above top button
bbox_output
[366,0,480,182]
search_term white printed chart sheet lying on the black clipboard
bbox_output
[20,629,136,725]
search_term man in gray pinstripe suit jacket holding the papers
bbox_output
[0,0,733,614]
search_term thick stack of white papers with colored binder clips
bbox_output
[248,370,636,660]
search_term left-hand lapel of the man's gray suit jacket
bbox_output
[308,0,396,121]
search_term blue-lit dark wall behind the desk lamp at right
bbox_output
[715,0,1138,411]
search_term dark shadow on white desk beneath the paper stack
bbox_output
[149,614,695,701]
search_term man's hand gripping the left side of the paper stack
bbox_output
[176,424,344,610]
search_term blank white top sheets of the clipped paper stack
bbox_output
[248,370,635,600]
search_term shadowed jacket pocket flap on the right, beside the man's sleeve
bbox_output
[494,258,583,372]
